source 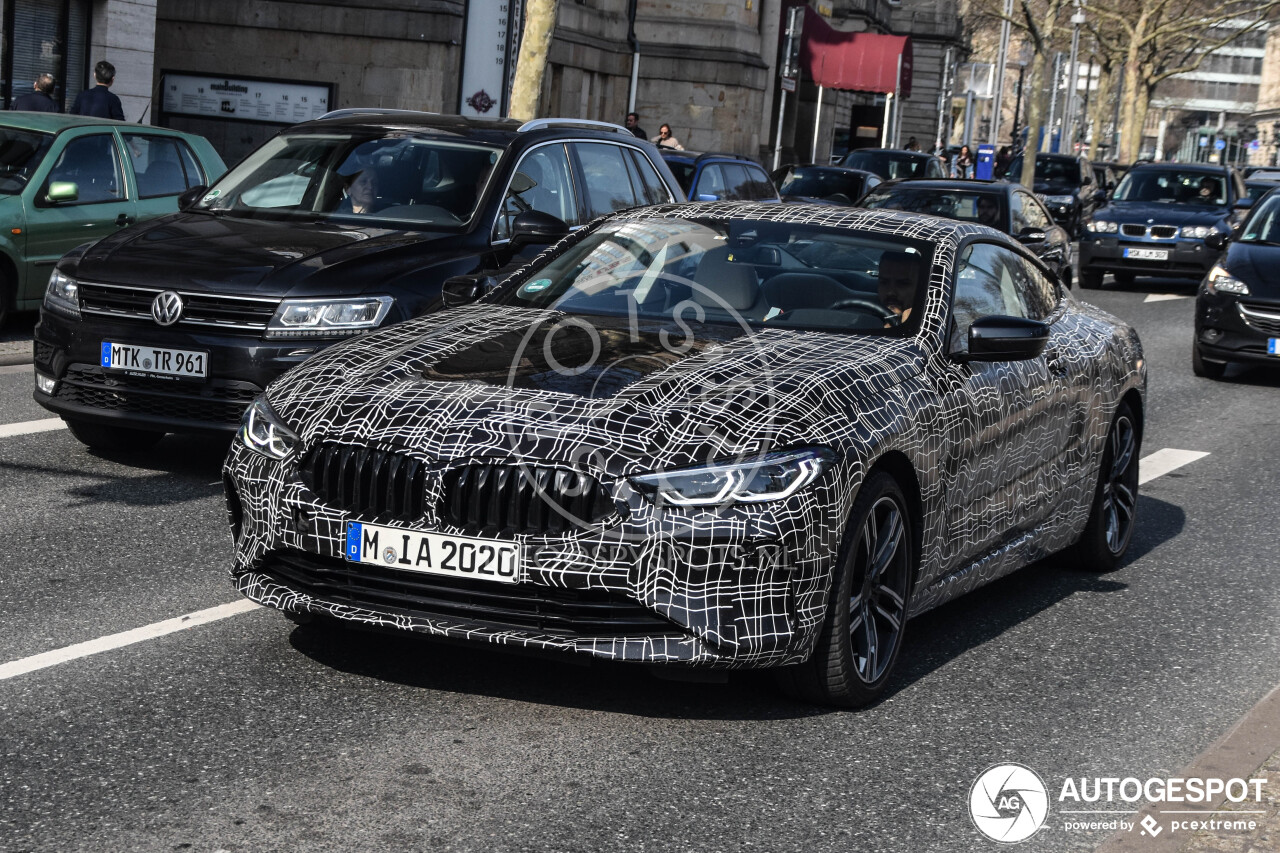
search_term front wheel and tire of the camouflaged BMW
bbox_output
[783,471,918,708]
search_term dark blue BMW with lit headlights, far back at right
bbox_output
[1080,163,1252,288]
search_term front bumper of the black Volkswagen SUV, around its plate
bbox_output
[33,310,343,433]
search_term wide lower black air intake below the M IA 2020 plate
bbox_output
[261,551,682,638]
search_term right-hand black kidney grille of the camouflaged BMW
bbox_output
[440,465,616,535]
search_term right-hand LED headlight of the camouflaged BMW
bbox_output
[630,447,836,506]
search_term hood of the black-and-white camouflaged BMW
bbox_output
[268,305,924,475]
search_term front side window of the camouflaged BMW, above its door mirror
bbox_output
[951,243,1030,352]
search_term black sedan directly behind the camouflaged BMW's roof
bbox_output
[859,181,1071,287]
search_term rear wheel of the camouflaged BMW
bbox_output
[1074,402,1142,571]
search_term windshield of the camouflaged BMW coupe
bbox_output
[495,219,932,334]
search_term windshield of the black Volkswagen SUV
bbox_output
[196,131,500,228]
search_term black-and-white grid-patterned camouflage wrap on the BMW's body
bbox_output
[225,204,1146,666]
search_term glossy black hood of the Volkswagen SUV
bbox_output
[66,213,458,296]
